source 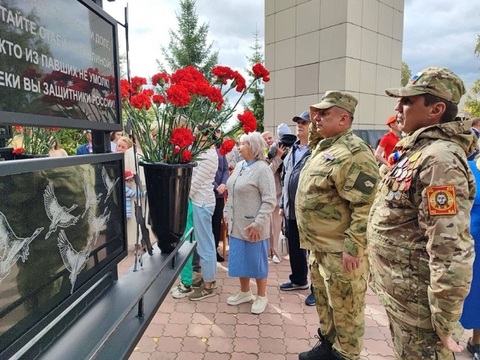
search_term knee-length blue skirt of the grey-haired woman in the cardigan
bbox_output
[228,236,269,279]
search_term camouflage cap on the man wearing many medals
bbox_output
[385,66,465,104]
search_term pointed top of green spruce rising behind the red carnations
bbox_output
[157,0,218,77]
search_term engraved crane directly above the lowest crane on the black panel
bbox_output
[43,182,80,239]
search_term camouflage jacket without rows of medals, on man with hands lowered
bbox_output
[295,129,379,257]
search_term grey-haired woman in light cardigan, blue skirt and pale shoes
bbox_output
[224,132,276,314]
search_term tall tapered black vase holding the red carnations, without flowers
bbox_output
[140,162,197,253]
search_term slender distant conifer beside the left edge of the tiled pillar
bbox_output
[244,29,265,132]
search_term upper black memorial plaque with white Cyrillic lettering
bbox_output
[0,0,121,130]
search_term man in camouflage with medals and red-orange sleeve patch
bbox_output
[367,67,475,360]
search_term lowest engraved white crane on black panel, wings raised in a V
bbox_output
[57,230,92,294]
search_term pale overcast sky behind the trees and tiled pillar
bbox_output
[104,0,480,87]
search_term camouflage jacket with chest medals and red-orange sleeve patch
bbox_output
[367,121,475,335]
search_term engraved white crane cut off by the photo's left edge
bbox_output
[0,212,44,283]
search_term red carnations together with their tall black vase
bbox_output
[121,64,269,253]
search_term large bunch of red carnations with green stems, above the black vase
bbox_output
[121,64,270,164]
